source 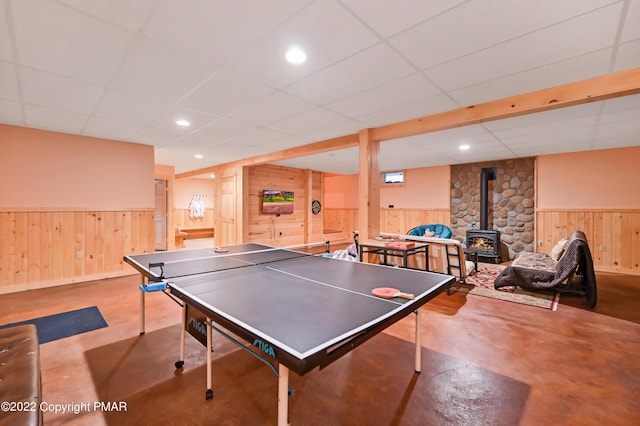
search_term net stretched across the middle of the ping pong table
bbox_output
[149,243,326,280]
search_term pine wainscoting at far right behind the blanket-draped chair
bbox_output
[536,210,640,275]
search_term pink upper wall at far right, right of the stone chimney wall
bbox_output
[536,146,640,209]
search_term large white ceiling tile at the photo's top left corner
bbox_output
[11,1,134,85]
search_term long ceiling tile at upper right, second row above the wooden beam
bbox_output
[425,4,621,90]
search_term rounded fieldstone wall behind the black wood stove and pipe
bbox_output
[451,157,535,260]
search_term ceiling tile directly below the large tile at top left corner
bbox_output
[19,68,104,114]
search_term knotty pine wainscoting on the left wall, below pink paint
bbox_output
[0,210,154,293]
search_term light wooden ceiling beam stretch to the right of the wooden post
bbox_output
[371,68,640,141]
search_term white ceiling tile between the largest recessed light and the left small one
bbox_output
[180,69,274,116]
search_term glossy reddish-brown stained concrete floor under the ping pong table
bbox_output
[0,273,640,426]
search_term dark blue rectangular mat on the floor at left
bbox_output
[0,306,109,344]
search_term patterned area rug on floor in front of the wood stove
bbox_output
[452,263,560,311]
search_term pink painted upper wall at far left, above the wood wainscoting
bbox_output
[0,125,155,210]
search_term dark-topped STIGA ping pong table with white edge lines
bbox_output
[125,243,454,425]
